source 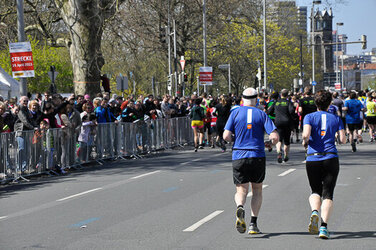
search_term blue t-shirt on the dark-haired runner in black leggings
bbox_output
[303,111,343,161]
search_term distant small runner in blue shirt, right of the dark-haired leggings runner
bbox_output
[342,92,363,152]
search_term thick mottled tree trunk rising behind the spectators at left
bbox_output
[55,0,114,97]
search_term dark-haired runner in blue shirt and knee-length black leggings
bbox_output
[302,90,346,239]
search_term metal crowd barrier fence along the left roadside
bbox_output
[0,117,193,181]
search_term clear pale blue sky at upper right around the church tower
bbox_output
[296,0,376,55]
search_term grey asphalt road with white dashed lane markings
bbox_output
[0,137,376,250]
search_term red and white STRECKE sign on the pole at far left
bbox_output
[9,42,35,78]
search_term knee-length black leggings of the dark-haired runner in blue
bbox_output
[306,157,339,200]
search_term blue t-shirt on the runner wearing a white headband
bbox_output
[225,106,276,160]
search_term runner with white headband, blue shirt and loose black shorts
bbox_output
[223,88,279,234]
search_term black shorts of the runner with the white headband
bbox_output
[232,157,266,184]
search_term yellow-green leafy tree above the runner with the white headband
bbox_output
[187,16,306,94]
